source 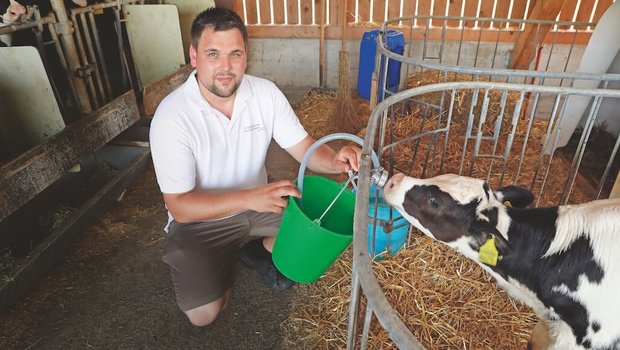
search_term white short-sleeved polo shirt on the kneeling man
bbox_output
[150,71,308,224]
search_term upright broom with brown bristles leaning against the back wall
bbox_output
[332,0,363,134]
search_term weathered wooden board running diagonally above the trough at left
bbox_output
[0,91,140,221]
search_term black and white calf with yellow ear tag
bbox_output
[384,174,620,350]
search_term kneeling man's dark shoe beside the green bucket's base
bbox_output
[239,239,295,290]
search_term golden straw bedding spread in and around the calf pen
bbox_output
[283,73,591,349]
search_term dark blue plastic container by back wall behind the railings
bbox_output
[357,29,405,101]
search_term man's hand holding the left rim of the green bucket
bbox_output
[248,180,301,213]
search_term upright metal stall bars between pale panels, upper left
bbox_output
[0,0,145,117]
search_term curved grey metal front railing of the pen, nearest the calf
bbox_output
[347,82,620,349]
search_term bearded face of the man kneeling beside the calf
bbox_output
[189,28,247,100]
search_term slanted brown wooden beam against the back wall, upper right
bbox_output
[509,0,566,69]
